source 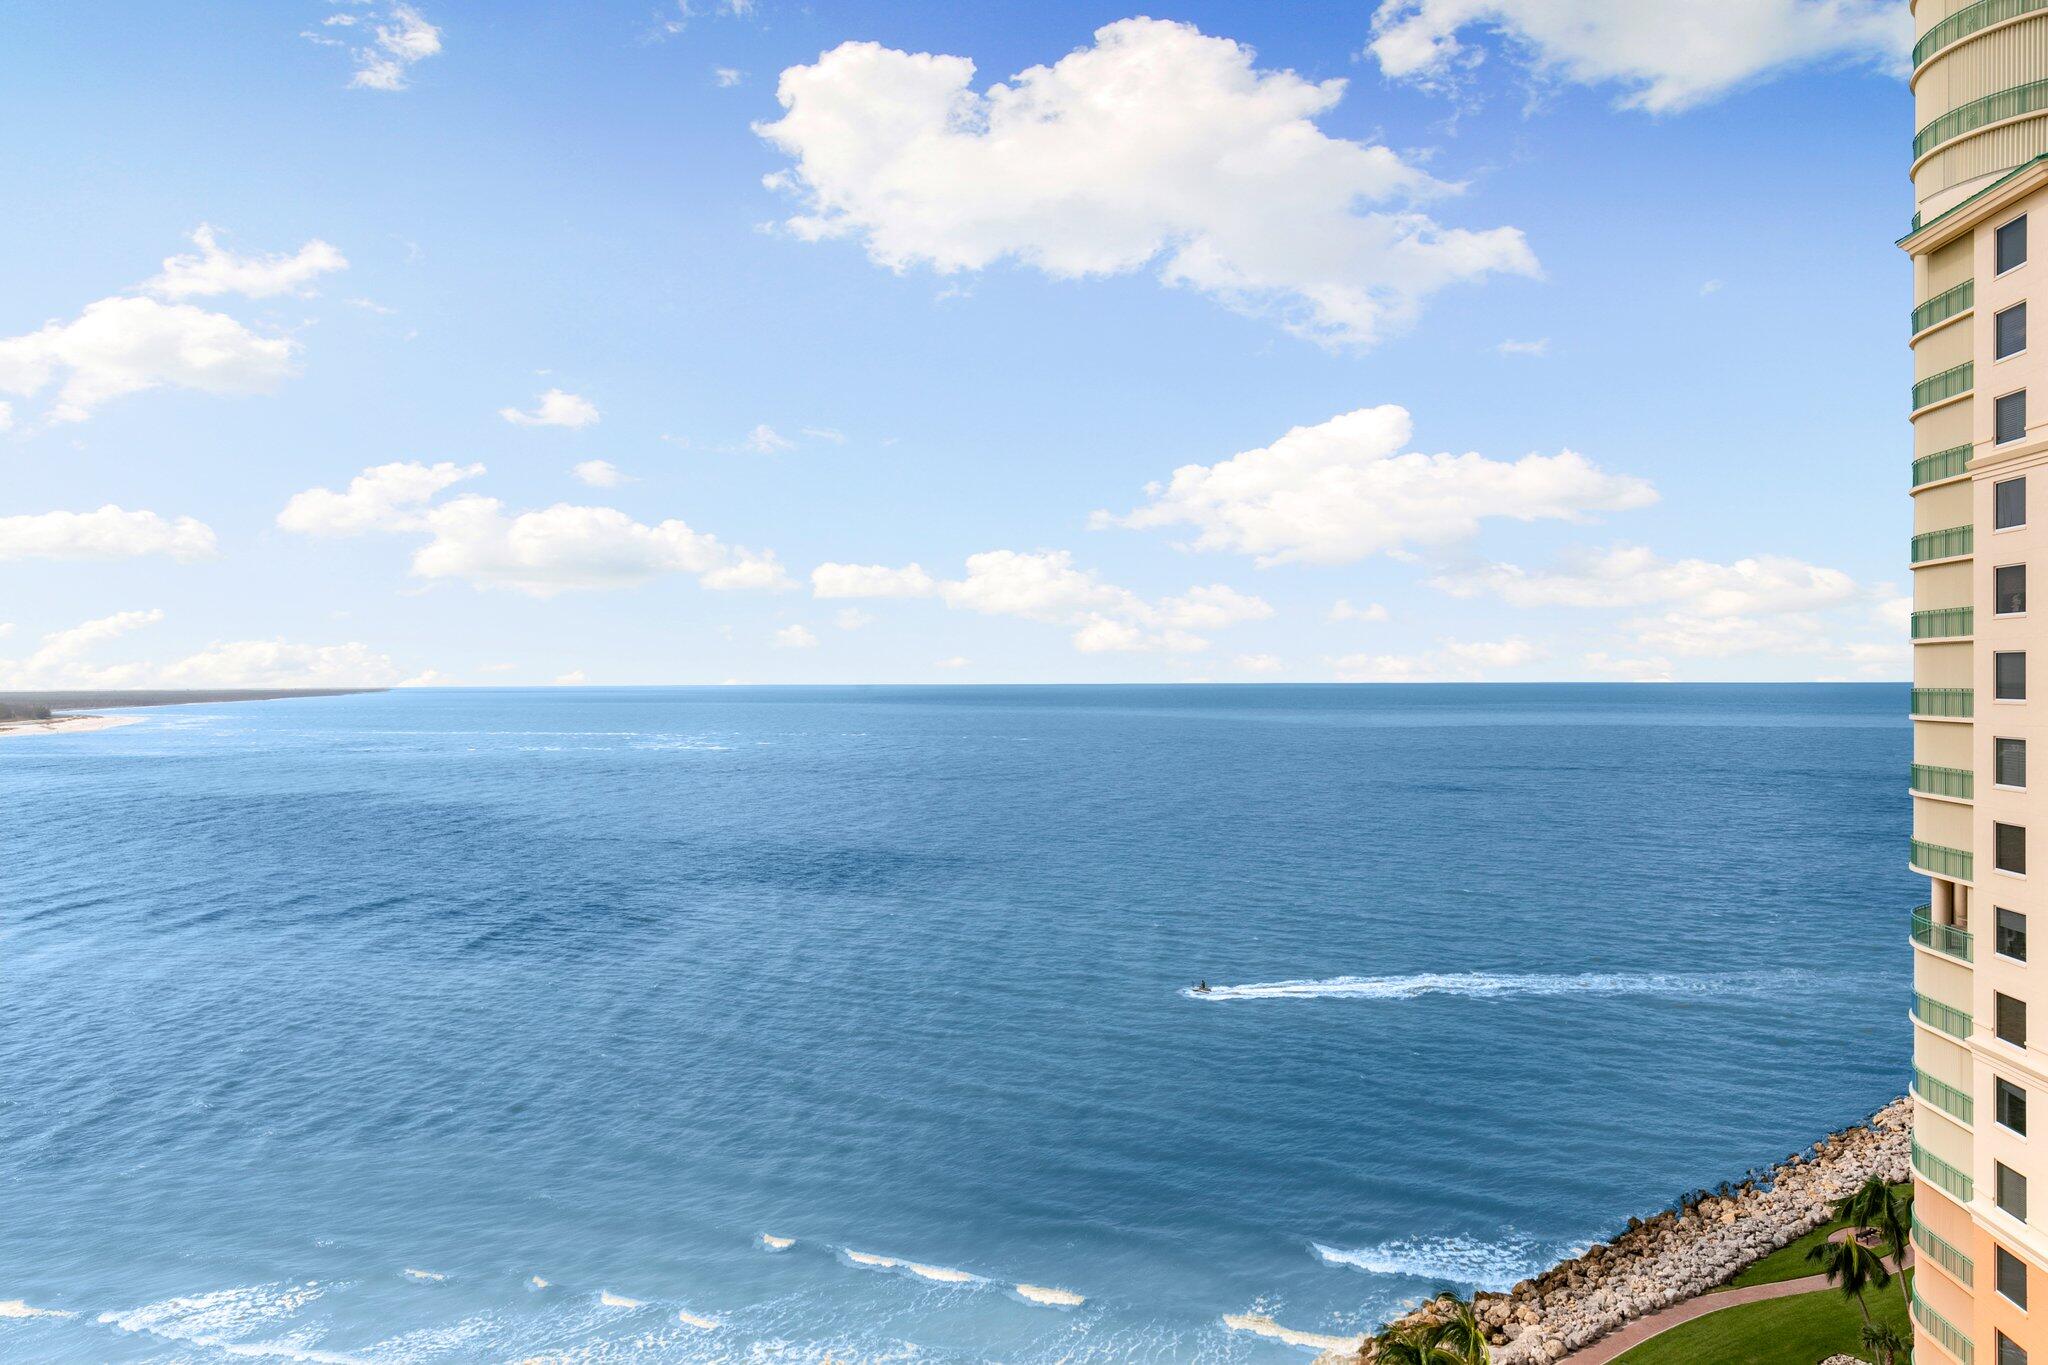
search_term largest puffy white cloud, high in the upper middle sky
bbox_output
[756,18,1538,346]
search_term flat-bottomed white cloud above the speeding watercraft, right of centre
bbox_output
[1096,403,1657,567]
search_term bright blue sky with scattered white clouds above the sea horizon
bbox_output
[0,0,1911,688]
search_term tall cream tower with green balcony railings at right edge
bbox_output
[1901,0,2048,1365]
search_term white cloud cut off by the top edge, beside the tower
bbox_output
[1370,0,1913,113]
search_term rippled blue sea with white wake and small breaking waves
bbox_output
[0,686,1915,1361]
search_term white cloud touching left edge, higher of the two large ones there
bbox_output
[0,297,299,422]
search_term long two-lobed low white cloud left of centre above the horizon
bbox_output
[279,463,788,598]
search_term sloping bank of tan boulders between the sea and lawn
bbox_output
[1317,1099,1913,1365]
